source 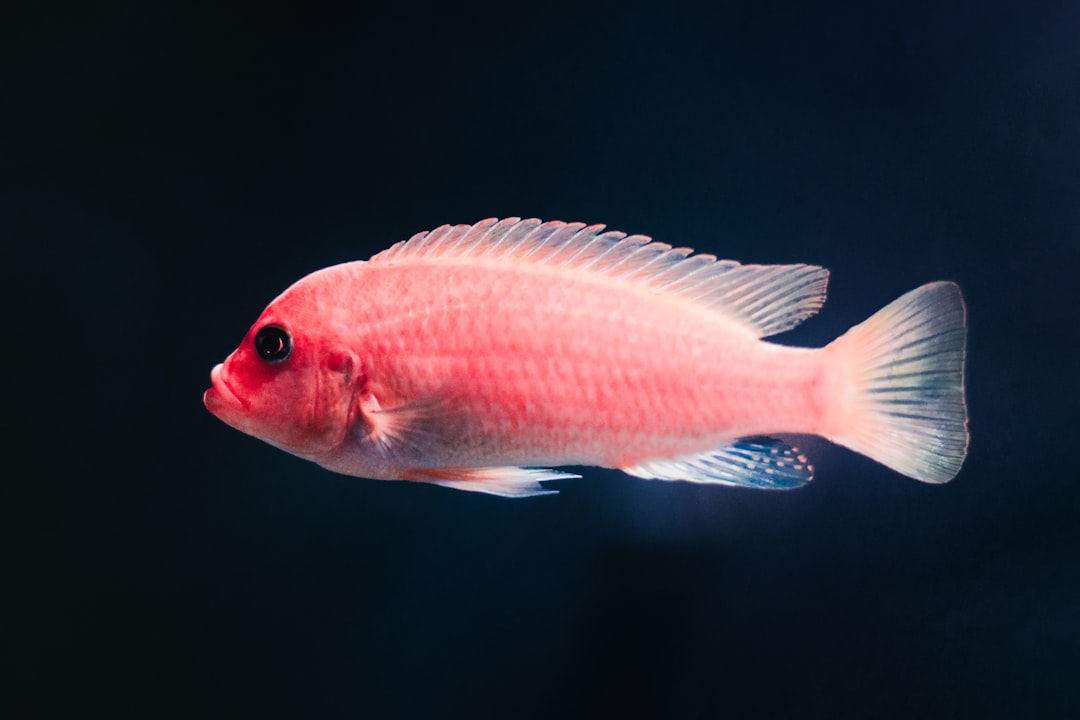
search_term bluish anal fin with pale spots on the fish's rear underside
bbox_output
[622,437,813,490]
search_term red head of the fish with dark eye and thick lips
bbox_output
[203,278,362,460]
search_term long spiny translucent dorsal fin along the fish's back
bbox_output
[370,218,828,337]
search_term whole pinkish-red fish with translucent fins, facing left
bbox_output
[203,217,969,498]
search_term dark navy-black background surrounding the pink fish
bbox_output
[8,0,1080,718]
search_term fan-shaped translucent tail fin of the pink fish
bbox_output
[826,282,968,483]
